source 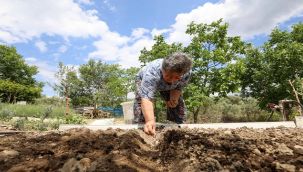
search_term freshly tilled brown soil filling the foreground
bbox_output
[0,128,303,171]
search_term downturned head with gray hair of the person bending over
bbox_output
[162,52,192,83]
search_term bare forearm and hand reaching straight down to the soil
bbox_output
[141,98,156,135]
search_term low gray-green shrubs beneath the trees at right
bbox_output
[188,96,282,123]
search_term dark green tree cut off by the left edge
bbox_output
[0,45,43,103]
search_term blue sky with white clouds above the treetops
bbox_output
[0,0,303,96]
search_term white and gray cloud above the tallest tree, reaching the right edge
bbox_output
[168,0,303,43]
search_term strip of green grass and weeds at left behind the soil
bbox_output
[0,103,85,131]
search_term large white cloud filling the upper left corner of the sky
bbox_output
[0,0,109,43]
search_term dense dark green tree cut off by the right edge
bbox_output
[242,23,303,108]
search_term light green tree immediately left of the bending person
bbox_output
[79,60,126,106]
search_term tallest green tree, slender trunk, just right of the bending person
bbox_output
[185,19,249,122]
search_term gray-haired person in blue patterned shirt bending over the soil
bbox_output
[134,53,192,135]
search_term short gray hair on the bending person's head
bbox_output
[162,52,192,74]
